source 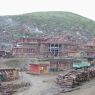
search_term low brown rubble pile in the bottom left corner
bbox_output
[0,82,31,95]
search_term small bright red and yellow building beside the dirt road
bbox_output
[29,60,50,74]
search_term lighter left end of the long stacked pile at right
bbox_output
[57,71,80,87]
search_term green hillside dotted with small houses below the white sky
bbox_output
[0,11,95,39]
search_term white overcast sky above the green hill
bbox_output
[0,0,95,20]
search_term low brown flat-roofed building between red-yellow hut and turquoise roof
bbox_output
[49,58,73,72]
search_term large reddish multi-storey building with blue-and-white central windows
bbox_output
[12,36,78,58]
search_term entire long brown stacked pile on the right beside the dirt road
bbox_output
[56,67,95,92]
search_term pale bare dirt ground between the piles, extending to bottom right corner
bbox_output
[15,73,95,95]
